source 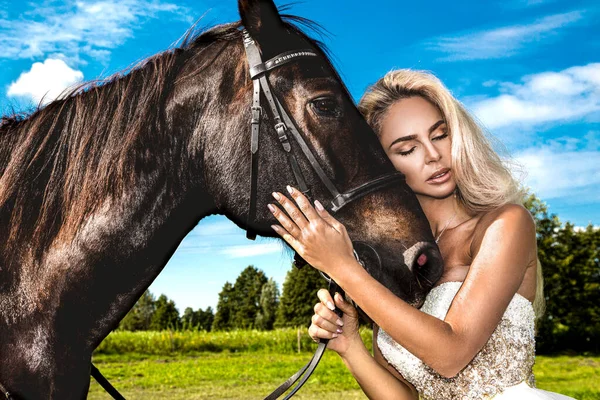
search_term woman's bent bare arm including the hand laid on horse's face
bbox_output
[274,190,536,377]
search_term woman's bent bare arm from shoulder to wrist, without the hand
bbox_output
[338,206,536,377]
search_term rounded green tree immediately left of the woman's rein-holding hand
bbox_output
[275,266,327,328]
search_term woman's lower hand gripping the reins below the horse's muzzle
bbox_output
[308,289,362,357]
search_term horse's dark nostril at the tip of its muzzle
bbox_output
[404,242,444,290]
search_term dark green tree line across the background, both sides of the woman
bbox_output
[121,194,600,354]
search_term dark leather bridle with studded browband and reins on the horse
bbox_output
[17,29,404,400]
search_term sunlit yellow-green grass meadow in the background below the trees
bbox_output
[88,329,600,400]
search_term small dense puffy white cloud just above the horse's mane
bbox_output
[7,58,83,104]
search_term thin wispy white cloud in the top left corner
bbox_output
[0,0,188,59]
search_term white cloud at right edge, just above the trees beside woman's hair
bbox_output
[514,136,600,204]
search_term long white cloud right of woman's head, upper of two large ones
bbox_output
[470,63,600,128]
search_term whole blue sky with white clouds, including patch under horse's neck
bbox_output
[0,0,600,312]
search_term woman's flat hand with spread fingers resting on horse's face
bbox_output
[268,186,356,276]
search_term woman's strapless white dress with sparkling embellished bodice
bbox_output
[377,282,573,400]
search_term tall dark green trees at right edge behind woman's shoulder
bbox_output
[524,194,600,354]
